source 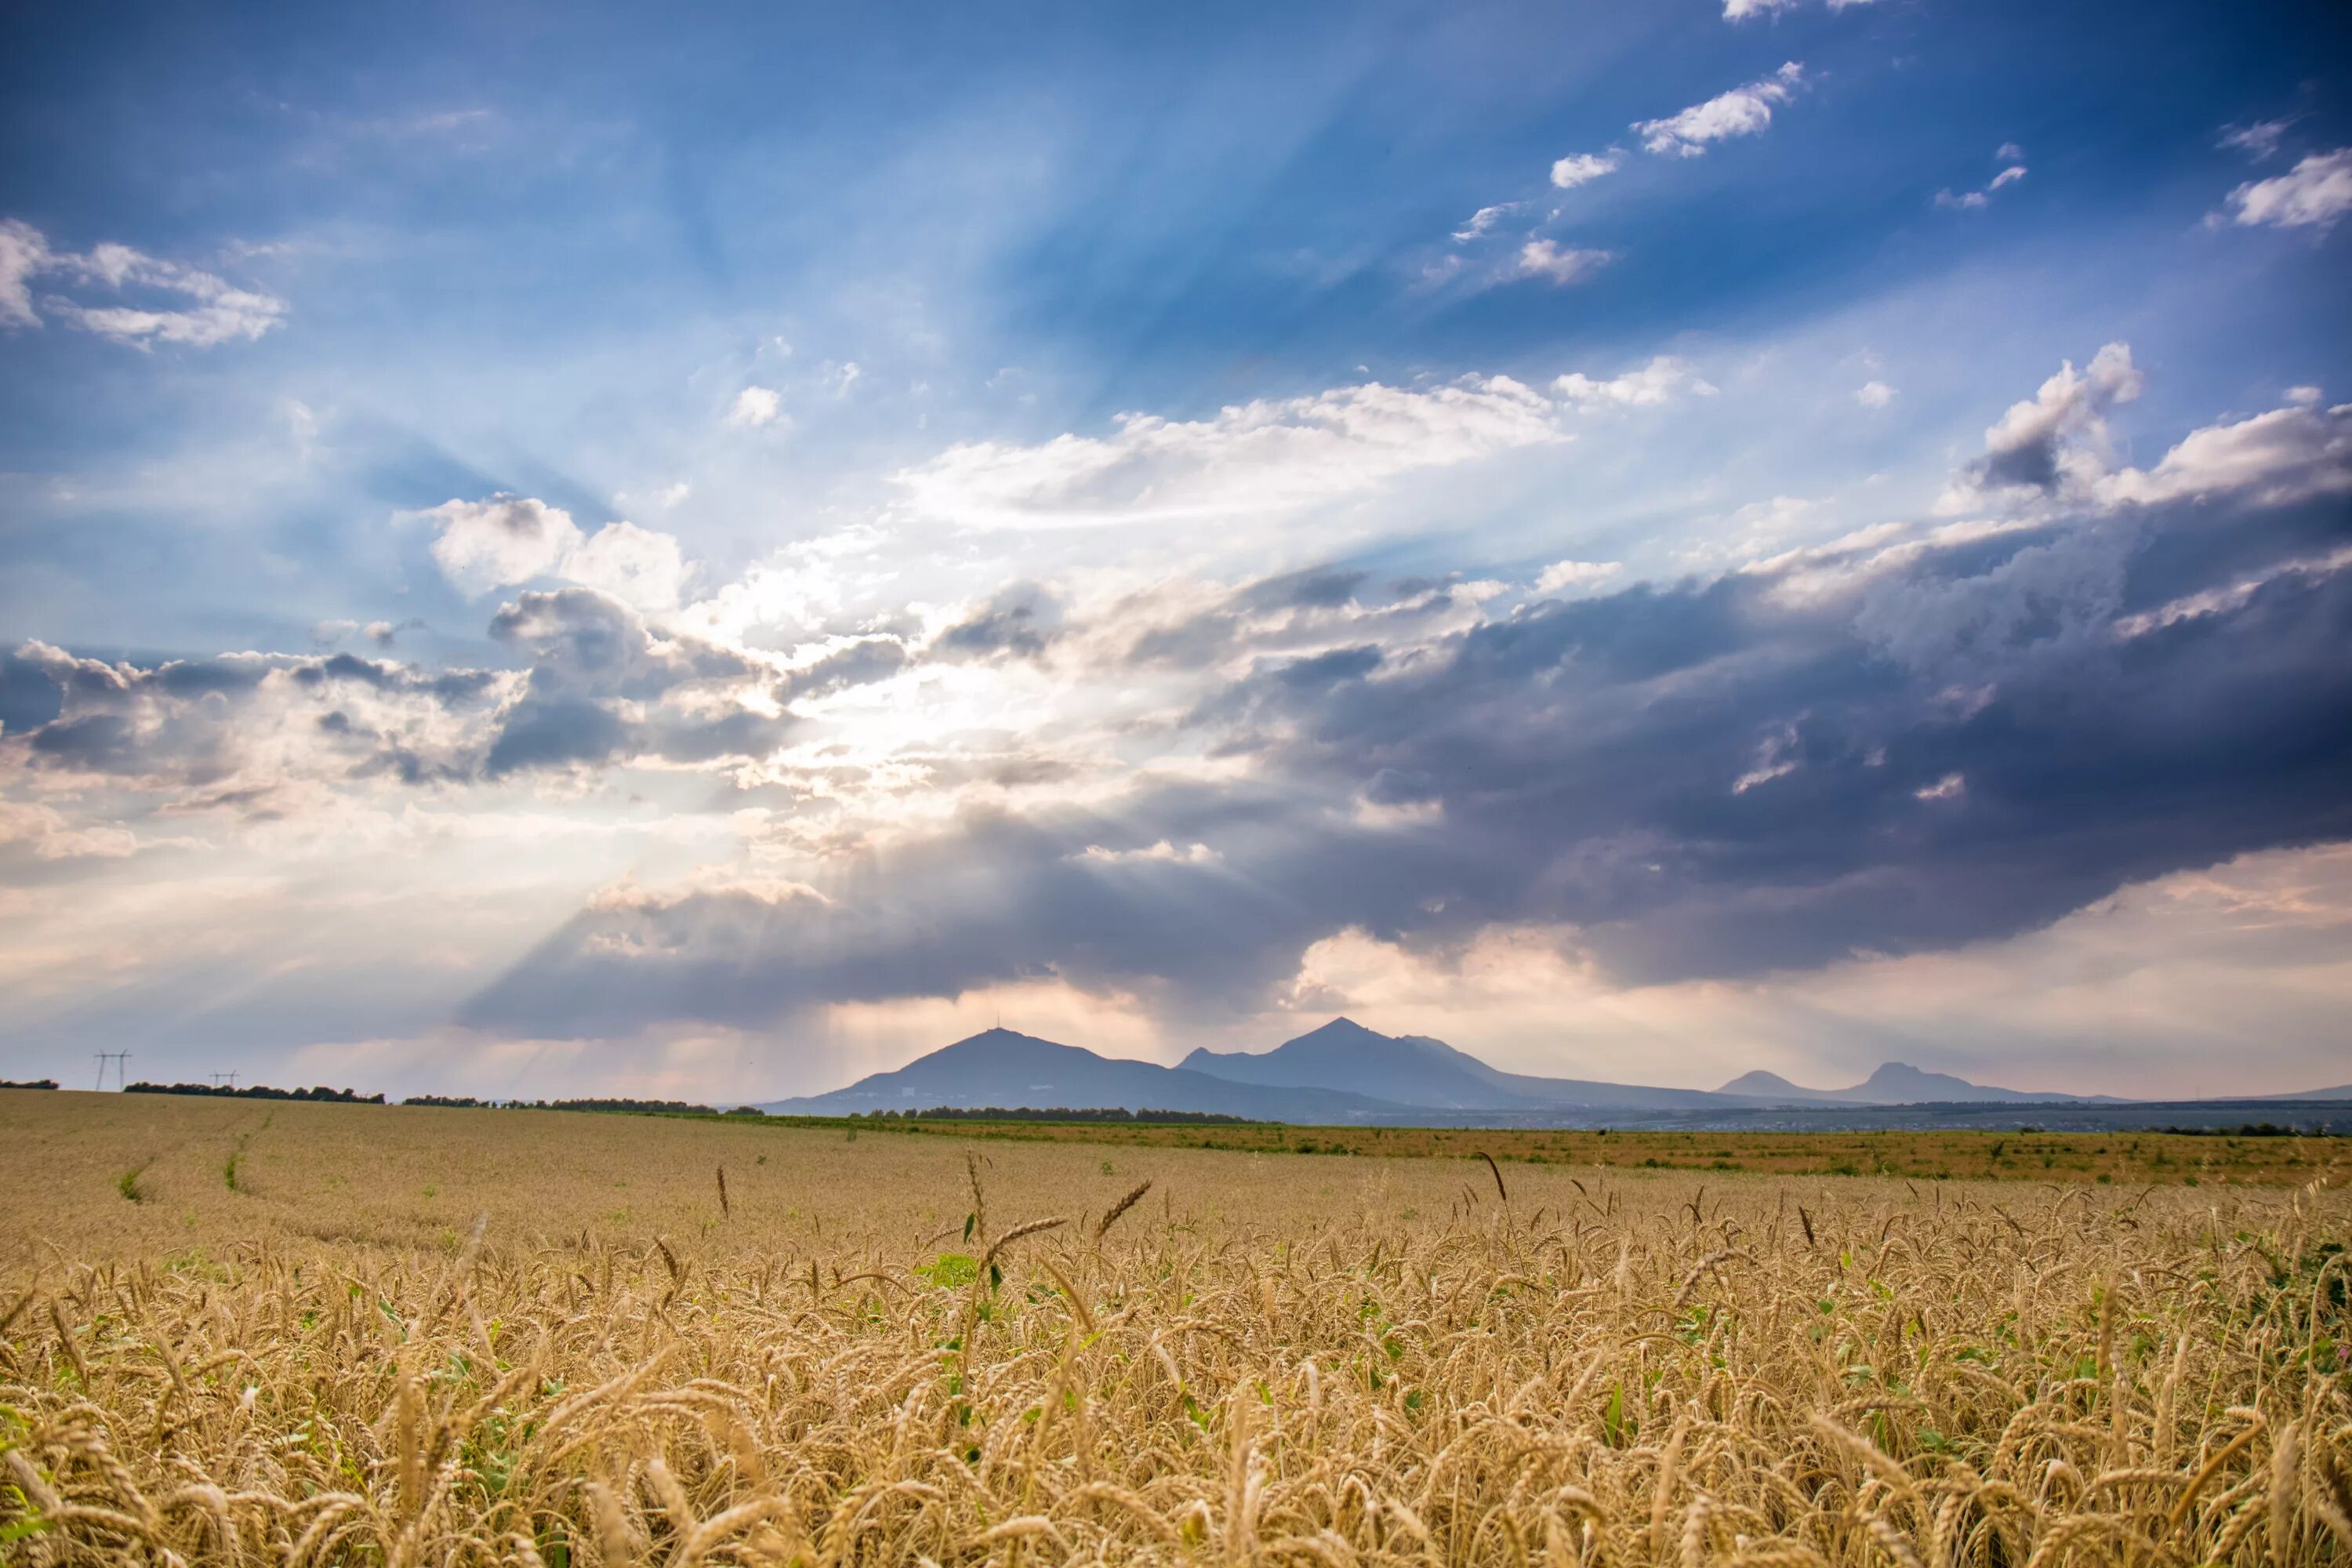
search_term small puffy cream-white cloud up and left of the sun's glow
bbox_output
[407,494,689,612]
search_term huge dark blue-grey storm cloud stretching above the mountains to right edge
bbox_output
[459,484,2352,1032]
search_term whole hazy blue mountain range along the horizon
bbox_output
[762,1018,2352,1123]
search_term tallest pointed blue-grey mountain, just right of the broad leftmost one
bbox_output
[1183,1018,1736,1112]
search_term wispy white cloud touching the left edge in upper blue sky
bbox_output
[0,219,287,348]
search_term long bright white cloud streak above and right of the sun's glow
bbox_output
[894,376,1564,529]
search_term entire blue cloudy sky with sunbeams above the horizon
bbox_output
[0,0,2352,1102]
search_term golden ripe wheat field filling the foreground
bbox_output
[0,1093,2352,1568]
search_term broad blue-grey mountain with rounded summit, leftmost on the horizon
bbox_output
[760,1029,1411,1123]
